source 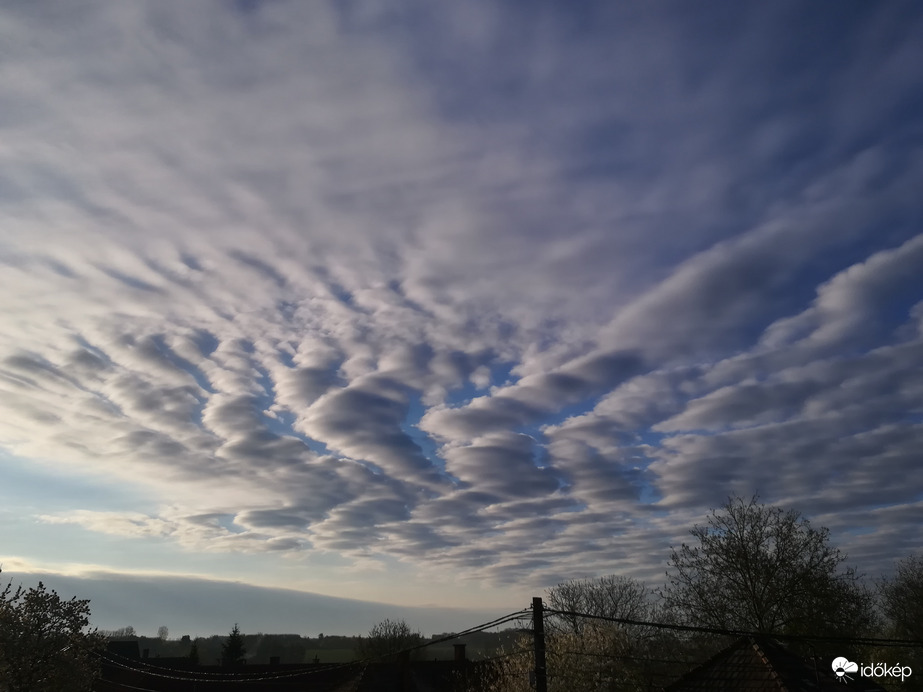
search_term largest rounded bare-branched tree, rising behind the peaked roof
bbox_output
[663,496,875,636]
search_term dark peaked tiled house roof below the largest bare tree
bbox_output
[665,637,885,692]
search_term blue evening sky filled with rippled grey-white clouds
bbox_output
[0,0,923,634]
